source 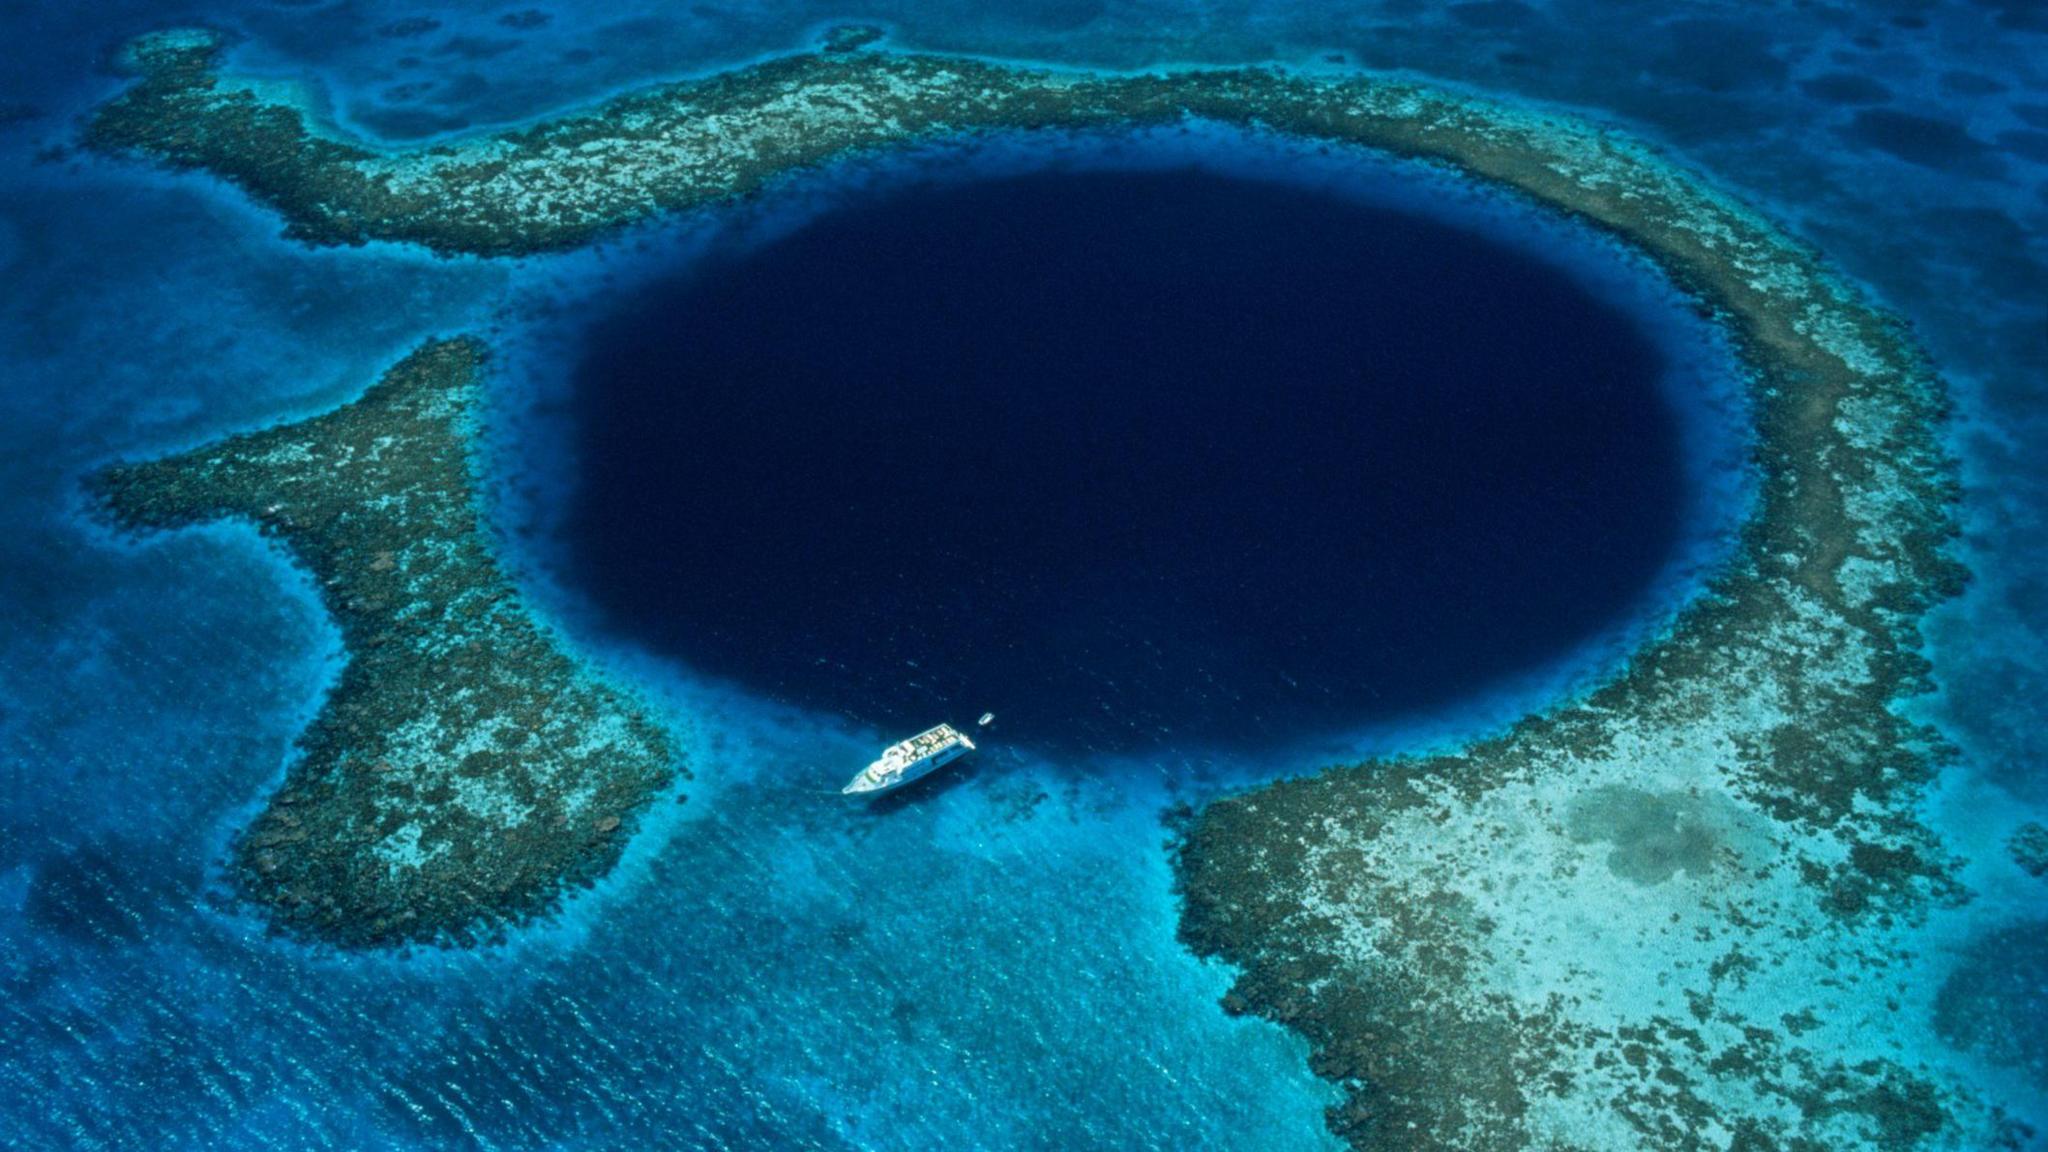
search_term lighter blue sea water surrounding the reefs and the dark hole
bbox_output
[0,0,2048,1150]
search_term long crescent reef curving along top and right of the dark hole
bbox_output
[86,31,2030,1150]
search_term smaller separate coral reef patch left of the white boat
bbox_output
[92,340,676,947]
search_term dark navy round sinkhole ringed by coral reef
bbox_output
[565,170,1686,752]
